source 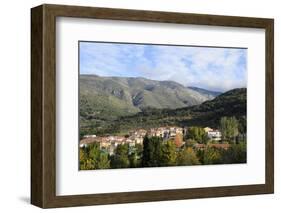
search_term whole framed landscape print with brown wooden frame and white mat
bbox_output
[31,5,274,208]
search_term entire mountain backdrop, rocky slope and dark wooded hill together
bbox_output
[79,75,247,135]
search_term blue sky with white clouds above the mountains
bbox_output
[79,42,247,91]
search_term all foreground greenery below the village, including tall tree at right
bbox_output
[79,117,247,170]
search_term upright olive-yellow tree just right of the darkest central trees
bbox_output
[159,141,177,166]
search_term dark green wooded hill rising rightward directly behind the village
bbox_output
[79,85,247,134]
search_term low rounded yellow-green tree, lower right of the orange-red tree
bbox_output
[177,147,200,166]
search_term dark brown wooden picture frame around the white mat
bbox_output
[31,5,274,208]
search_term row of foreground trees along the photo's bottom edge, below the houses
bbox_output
[80,137,247,170]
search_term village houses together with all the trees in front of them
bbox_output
[79,117,247,170]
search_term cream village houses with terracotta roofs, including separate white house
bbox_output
[80,126,221,155]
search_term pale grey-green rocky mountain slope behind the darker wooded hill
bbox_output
[79,75,218,123]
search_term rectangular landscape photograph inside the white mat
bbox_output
[78,41,247,170]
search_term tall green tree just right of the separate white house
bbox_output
[220,117,239,143]
